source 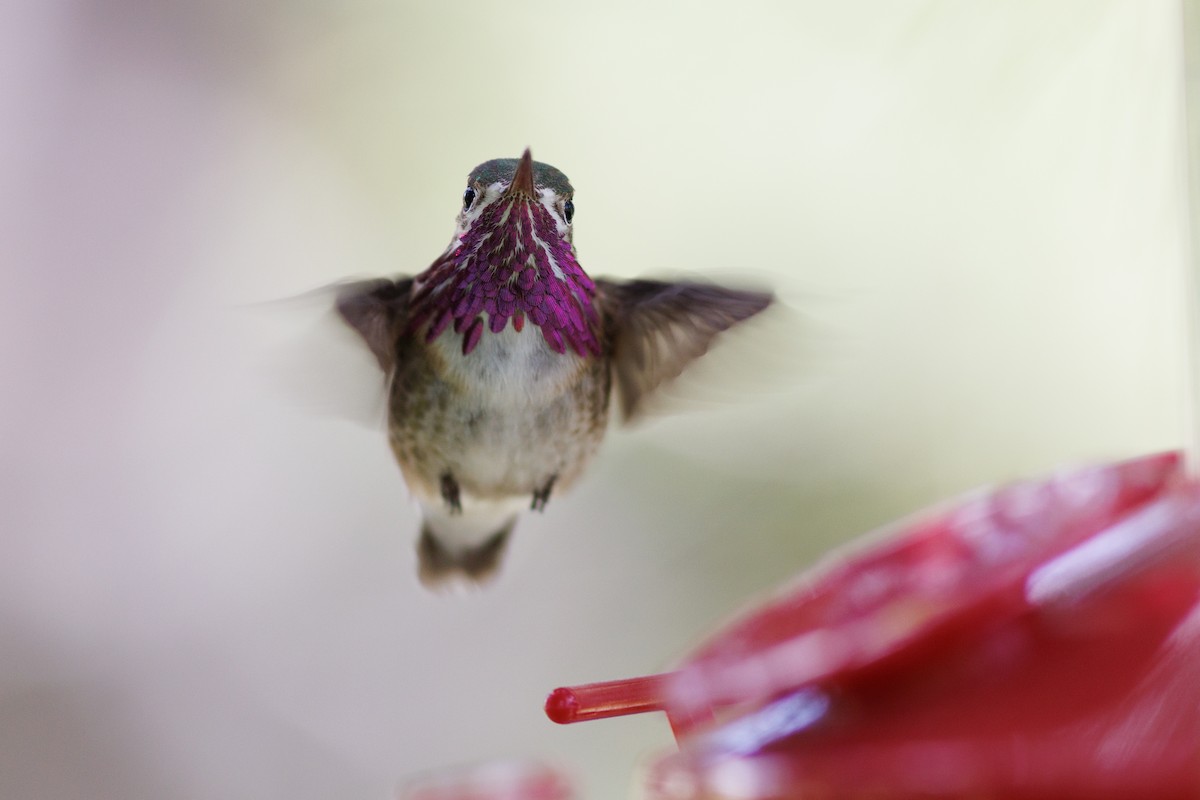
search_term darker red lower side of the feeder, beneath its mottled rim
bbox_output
[653,564,1200,800]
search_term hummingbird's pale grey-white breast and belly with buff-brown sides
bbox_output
[389,326,611,512]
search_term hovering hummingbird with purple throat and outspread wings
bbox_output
[336,150,772,583]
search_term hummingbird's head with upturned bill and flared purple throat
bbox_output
[409,150,600,356]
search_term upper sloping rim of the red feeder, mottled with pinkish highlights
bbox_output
[668,453,1180,710]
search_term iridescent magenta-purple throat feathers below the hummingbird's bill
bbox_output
[409,197,600,356]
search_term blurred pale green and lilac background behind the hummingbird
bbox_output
[0,0,1186,800]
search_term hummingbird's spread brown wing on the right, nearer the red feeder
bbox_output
[596,279,774,422]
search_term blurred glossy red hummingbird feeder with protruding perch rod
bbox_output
[552,455,1200,800]
